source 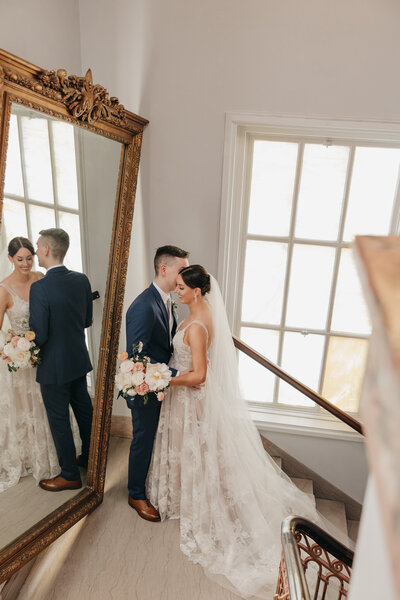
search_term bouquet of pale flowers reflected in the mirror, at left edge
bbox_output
[0,329,41,372]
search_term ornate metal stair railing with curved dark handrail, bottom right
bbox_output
[274,516,354,600]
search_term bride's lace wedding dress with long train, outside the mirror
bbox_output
[147,321,340,600]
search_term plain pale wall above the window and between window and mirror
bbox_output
[80,0,400,272]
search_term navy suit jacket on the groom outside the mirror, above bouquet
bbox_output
[126,284,176,408]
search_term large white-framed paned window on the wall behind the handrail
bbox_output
[220,119,400,413]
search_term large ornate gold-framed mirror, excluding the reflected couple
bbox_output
[0,50,147,583]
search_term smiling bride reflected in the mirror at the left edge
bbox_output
[0,237,80,492]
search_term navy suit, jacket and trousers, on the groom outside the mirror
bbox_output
[126,284,176,500]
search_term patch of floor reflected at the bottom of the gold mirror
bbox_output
[0,469,86,548]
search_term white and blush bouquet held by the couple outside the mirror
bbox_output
[115,342,172,404]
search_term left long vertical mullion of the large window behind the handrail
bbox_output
[273,143,304,404]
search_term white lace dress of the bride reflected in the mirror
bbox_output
[0,283,80,492]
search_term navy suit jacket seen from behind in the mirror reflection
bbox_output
[29,265,93,385]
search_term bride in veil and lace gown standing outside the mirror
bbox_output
[147,265,346,600]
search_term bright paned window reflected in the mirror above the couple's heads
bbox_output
[3,105,83,271]
